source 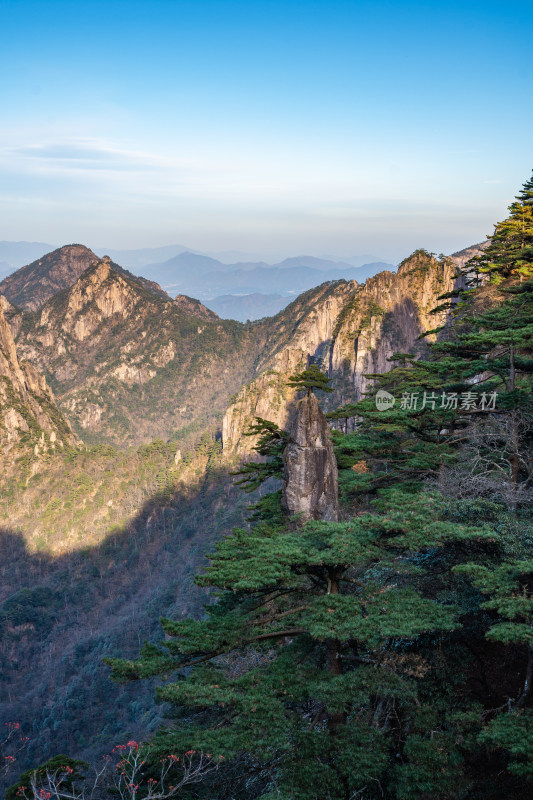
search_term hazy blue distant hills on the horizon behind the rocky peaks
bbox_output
[0,241,393,322]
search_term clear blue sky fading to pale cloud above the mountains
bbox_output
[0,0,533,261]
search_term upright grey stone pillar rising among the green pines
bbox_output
[282,394,339,522]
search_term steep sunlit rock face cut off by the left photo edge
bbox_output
[0,302,74,474]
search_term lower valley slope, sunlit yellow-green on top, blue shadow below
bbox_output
[0,454,254,784]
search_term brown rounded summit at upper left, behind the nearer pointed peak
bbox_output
[0,244,166,311]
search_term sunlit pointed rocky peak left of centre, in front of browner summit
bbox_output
[17,258,257,445]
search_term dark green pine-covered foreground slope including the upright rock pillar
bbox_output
[100,172,533,800]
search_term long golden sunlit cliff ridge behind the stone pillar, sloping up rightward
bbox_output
[223,245,483,456]
